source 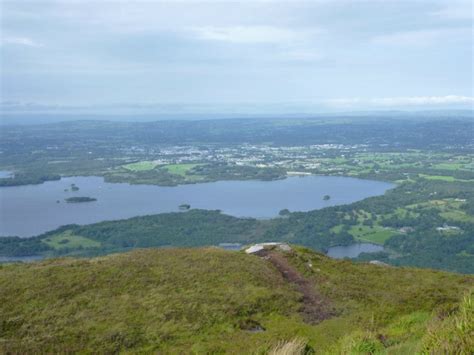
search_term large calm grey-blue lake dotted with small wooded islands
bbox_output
[0,176,393,237]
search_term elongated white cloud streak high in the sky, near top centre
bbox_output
[192,26,320,43]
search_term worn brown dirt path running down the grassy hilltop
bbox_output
[258,250,334,324]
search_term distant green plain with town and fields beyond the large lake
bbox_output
[0,115,474,186]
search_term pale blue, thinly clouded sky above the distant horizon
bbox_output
[0,0,474,111]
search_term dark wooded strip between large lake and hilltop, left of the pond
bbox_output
[0,209,352,256]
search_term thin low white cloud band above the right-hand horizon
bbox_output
[326,95,474,107]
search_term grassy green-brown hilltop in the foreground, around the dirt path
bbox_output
[0,248,474,354]
